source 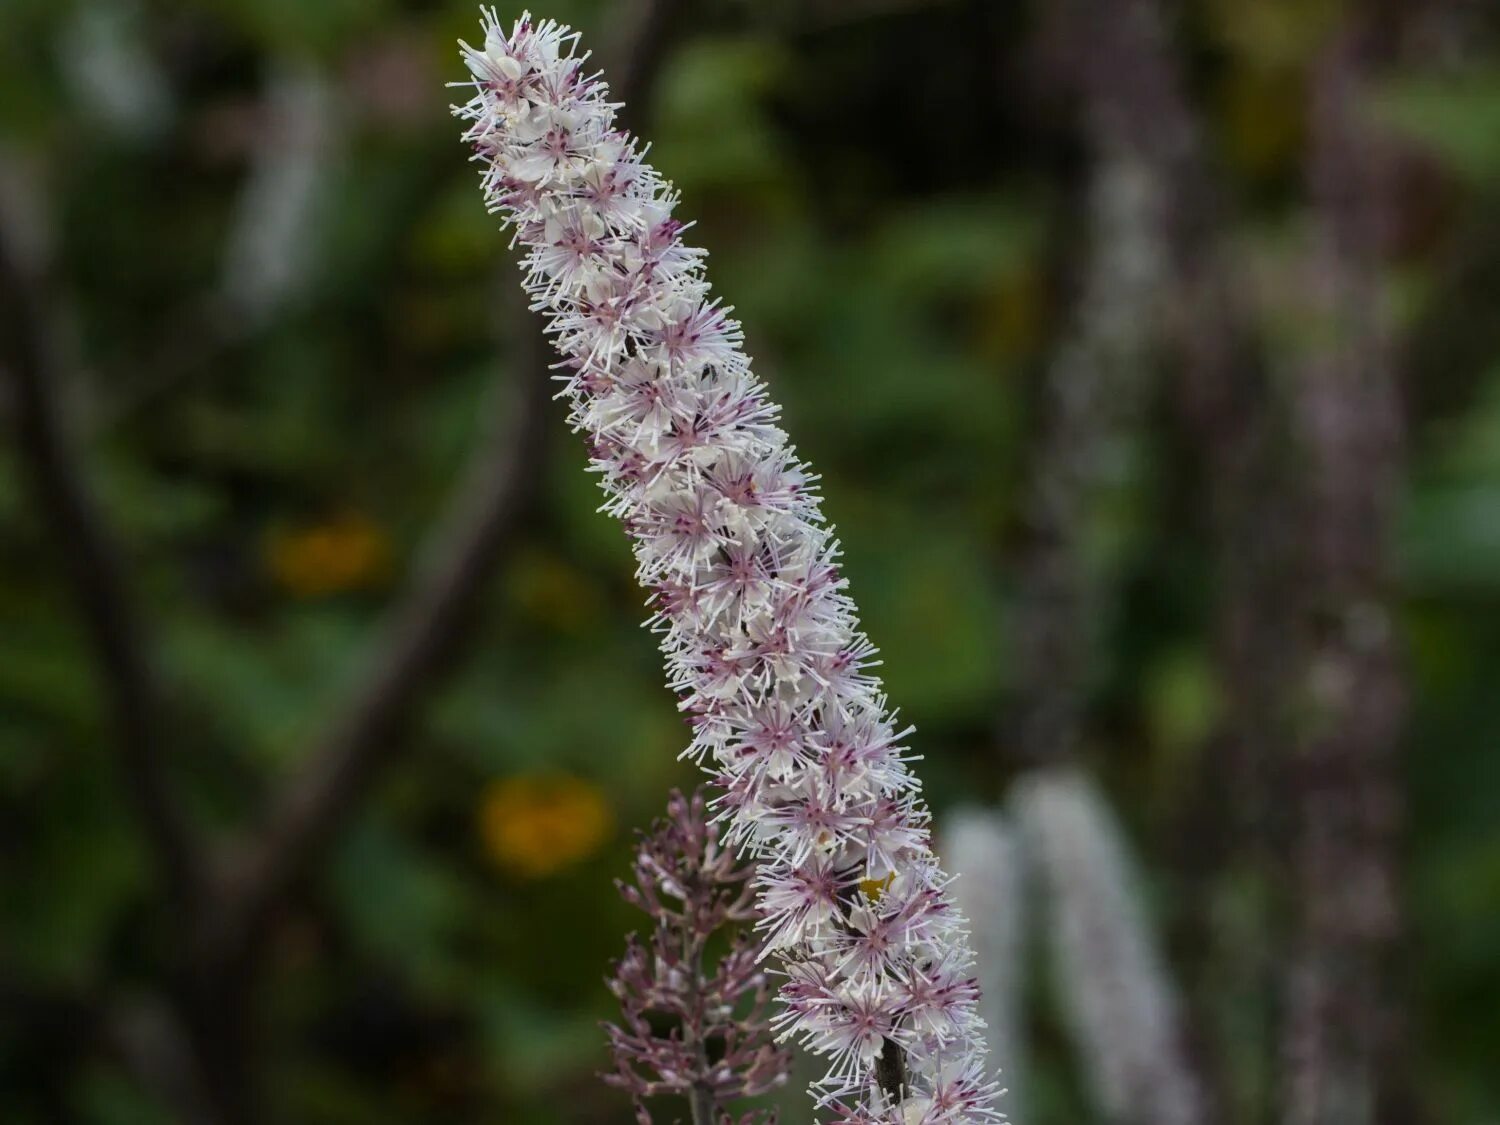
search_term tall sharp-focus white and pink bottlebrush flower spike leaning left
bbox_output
[455,11,1001,1125]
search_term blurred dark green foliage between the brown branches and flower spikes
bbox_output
[0,0,1500,1125]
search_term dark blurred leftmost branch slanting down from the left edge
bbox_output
[0,187,200,903]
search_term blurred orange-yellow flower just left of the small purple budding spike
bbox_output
[479,774,614,879]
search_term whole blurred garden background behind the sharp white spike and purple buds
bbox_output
[0,0,1500,1125]
